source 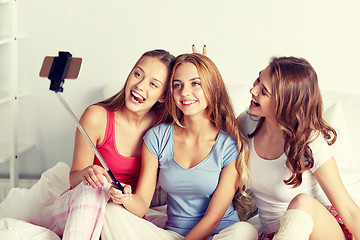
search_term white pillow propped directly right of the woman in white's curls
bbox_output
[323,101,360,170]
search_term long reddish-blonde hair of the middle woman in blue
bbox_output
[165,53,250,218]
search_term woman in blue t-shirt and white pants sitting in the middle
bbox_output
[104,53,257,240]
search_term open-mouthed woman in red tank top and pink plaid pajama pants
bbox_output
[53,50,175,240]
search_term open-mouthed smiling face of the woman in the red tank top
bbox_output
[125,56,169,112]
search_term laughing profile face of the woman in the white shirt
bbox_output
[249,66,275,118]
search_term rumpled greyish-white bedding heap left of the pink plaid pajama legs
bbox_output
[0,162,70,229]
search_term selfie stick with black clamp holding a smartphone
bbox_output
[40,52,124,192]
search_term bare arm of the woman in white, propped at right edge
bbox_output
[315,157,360,239]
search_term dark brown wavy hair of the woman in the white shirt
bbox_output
[250,57,337,187]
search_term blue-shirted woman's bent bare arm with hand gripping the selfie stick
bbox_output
[110,143,159,217]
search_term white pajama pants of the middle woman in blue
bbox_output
[101,203,257,240]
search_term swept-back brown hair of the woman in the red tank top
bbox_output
[97,49,175,112]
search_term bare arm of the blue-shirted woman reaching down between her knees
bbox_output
[185,161,239,240]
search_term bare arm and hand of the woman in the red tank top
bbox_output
[69,106,111,187]
